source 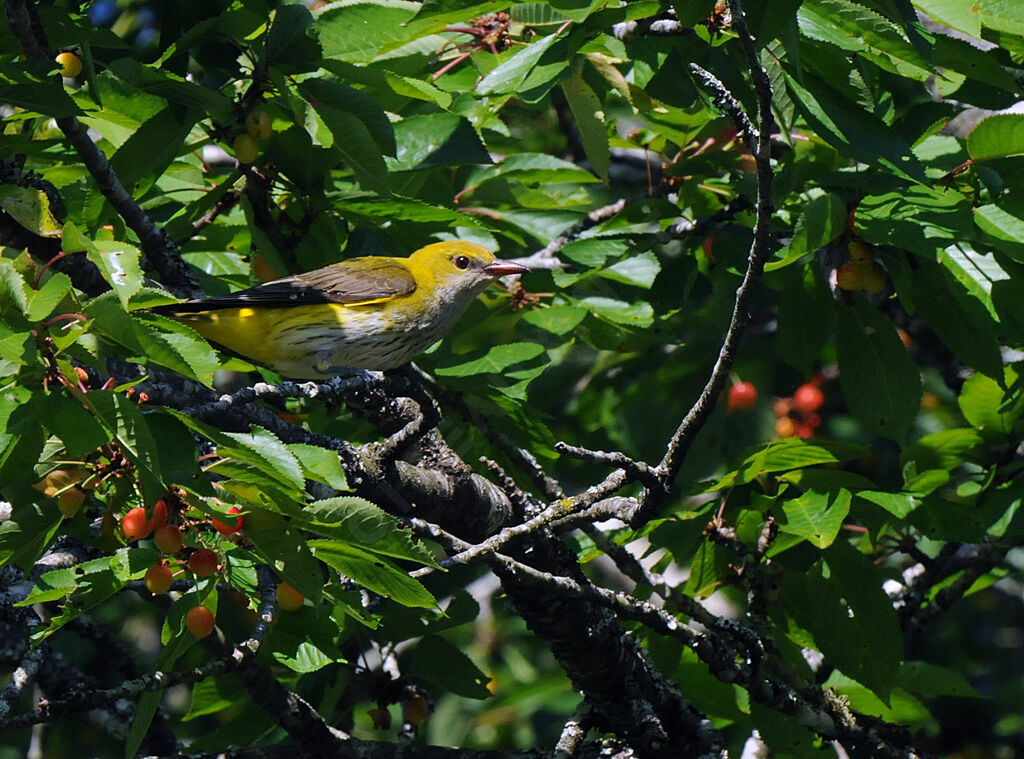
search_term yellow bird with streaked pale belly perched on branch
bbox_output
[157,240,529,380]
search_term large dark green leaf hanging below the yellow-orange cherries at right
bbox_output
[836,297,921,440]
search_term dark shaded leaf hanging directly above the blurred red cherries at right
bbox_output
[776,261,836,377]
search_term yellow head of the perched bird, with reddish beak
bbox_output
[409,240,529,301]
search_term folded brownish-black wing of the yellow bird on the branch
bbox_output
[154,256,416,313]
